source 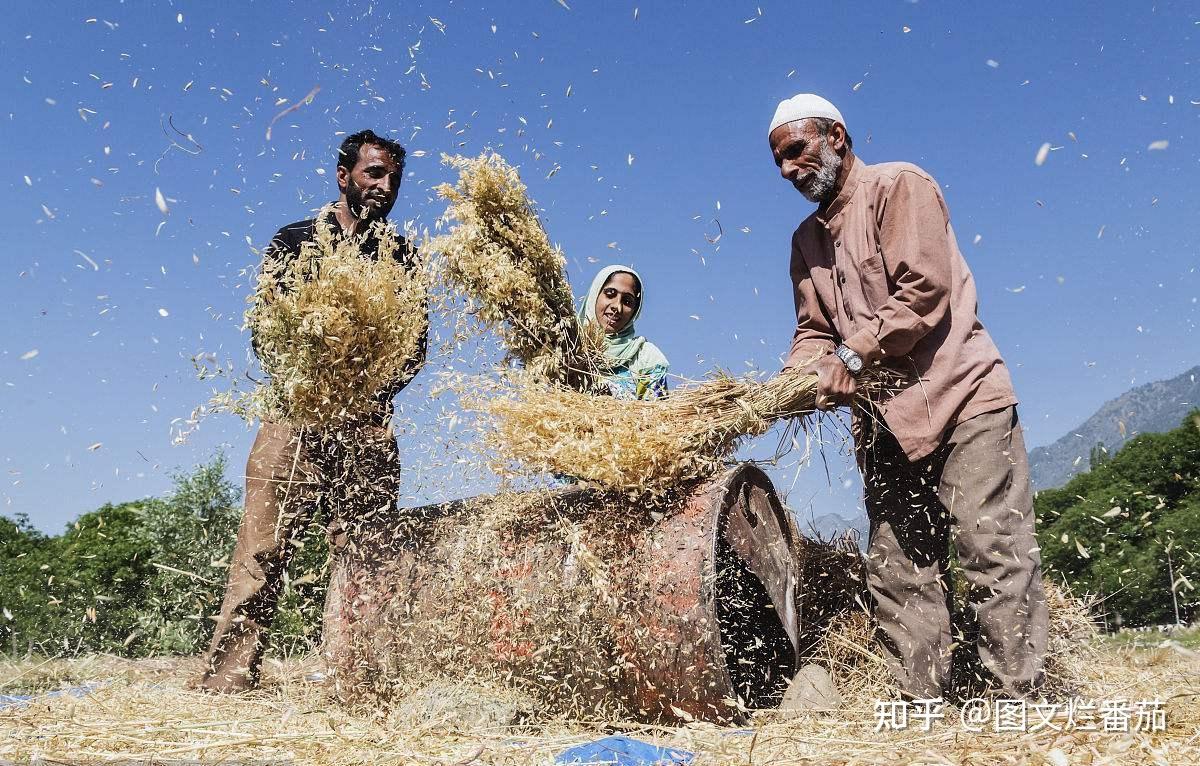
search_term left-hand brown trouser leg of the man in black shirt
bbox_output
[198,423,319,692]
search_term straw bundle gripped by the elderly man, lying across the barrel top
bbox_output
[467,373,840,495]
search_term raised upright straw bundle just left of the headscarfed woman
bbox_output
[430,152,604,389]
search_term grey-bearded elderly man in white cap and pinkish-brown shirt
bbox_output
[768,94,1046,699]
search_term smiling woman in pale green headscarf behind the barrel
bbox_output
[580,265,670,399]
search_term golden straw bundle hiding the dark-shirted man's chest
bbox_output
[246,209,427,426]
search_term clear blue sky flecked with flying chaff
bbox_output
[0,0,1200,531]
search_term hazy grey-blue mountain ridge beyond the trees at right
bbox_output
[1030,365,1200,490]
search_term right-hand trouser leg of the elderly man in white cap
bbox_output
[938,407,1049,699]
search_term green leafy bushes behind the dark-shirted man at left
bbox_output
[0,456,328,657]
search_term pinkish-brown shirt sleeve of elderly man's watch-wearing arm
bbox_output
[846,170,954,363]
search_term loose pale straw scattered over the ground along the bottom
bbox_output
[0,619,1200,766]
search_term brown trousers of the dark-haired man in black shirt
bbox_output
[196,421,400,692]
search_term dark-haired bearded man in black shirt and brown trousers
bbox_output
[196,131,425,692]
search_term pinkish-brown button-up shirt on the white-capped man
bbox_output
[785,152,1016,460]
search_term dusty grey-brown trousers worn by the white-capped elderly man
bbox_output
[858,407,1049,699]
